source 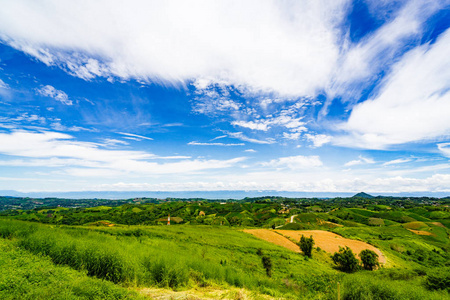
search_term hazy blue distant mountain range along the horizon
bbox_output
[0,190,449,199]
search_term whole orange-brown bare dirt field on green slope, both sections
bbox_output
[244,229,386,264]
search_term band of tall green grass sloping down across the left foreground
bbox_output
[0,220,288,289]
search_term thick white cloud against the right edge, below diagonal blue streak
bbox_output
[336,29,450,149]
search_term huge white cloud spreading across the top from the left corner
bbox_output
[0,0,347,96]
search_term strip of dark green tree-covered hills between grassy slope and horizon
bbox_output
[0,197,450,229]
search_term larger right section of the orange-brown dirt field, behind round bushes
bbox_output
[276,230,386,264]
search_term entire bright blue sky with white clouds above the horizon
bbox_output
[0,0,450,195]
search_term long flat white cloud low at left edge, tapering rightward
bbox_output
[0,131,245,176]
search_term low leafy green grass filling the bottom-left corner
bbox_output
[0,239,142,300]
